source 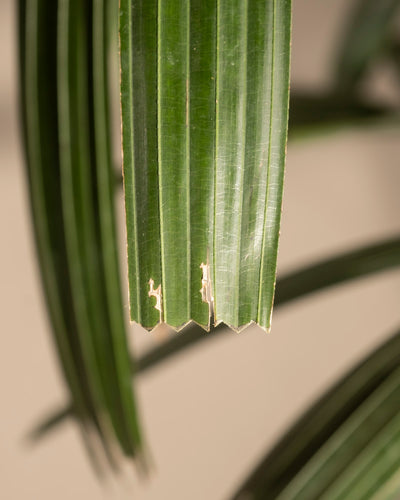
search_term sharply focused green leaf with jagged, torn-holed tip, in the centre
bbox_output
[120,0,291,329]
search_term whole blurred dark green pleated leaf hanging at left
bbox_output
[19,0,141,460]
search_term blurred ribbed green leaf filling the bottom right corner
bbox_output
[233,326,400,500]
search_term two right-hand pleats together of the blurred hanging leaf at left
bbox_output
[57,0,143,456]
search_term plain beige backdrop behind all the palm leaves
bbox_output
[0,0,400,500]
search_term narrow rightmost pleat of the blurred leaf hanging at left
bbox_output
[92,0,142,455]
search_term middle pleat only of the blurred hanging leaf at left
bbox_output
[57,0,128,452]
